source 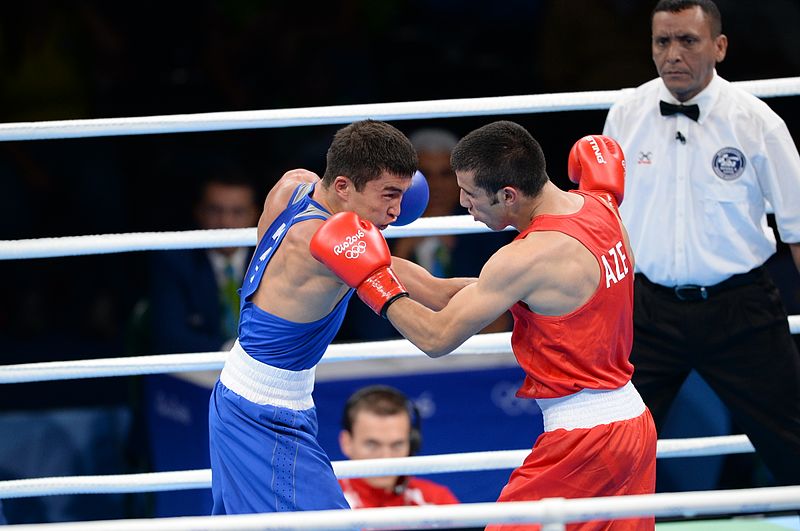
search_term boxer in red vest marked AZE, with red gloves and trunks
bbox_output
[311,121,656,531]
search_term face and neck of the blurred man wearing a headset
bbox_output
[339,410,411,490]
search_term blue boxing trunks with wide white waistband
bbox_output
[209,342,349,514]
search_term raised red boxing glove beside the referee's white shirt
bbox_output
[567,135,625,207]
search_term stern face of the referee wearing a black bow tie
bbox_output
[652,6,728,101]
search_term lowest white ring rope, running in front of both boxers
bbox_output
[6,487,800,531]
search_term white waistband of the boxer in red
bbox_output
[536,382,645,431]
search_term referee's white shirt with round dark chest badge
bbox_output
[603,73,800,286]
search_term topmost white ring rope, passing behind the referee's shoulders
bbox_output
[0,77,800,141]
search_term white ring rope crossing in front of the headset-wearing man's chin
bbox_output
[0,435,755,499]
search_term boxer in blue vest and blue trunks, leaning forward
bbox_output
[209,120,473,514]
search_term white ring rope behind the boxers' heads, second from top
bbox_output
[0,215,490,260]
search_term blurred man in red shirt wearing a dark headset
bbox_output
[339,385,458,509]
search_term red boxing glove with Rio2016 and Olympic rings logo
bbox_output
[309,212,408,318]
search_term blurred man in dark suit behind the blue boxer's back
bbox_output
[144,168,259,353]
